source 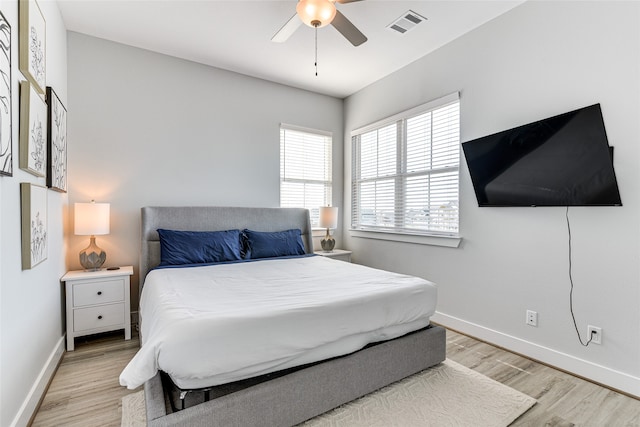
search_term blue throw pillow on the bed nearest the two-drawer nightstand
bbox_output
[158,229,242,265]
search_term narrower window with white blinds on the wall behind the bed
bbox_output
[280,124,333,227]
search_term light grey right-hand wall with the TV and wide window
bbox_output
[343,1,640,395]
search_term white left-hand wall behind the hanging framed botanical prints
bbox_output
[0,1,68,426]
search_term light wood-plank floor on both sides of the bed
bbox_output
[33,330,640,427]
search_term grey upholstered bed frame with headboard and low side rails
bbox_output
[140,206,445,427]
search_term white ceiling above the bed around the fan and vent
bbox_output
[58,0,524,98]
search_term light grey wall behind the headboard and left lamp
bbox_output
[68,33,343,310]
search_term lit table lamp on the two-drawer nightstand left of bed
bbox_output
[74,201,109,271]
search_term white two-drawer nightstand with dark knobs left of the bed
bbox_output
[61,266,133,351]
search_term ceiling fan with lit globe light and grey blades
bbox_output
[271,0,367,46]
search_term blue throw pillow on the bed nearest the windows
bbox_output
[243,229,305,259]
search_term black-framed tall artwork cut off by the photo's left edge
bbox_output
[0,11,13,176]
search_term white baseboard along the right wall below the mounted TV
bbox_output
[431,312,640,398]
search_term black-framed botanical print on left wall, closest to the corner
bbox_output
[47,86,67,193]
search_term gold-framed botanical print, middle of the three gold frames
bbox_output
[20,81,47,176]
